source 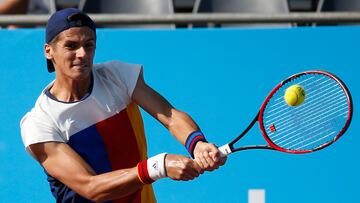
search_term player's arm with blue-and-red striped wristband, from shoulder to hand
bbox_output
[132,70,225,171]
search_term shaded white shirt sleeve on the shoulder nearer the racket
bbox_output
[102,61,142,98]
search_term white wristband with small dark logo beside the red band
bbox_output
[147,153,166,181]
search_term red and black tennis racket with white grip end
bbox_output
[219,70,353,156]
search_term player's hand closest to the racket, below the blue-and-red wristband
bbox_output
[194,141,226,171]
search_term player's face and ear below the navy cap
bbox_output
[45,27,96,80]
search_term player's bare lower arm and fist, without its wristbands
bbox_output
[29,142,201,202]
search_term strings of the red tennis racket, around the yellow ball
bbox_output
[263,74,349,150]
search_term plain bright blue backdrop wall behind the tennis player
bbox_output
[0,27,360,203]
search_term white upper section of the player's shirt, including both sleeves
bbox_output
[20,61,141,154]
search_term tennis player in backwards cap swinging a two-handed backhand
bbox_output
[21,8,225,203]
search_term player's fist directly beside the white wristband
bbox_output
[165,154,203,181]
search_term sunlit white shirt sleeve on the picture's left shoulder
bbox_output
[20,112,65,155]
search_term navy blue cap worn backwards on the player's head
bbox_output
[46,8,96,72]
